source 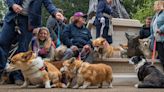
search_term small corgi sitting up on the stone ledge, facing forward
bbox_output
[92,37,120,59]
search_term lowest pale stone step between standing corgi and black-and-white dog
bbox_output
[112,73,138,86]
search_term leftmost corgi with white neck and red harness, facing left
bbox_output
[8,51,65,88]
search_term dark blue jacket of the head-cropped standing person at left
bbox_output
[5,0,57,28]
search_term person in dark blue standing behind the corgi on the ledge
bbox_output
[94,0,112,44]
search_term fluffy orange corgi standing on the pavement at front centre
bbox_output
[62,57,113,89]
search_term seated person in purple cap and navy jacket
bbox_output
[62,12,92,62]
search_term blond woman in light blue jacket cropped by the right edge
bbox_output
[150,0,164,69]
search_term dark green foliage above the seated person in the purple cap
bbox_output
[42,0,89,25]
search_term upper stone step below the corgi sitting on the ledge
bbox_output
[94,58,162,73]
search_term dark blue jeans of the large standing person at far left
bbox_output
[0,15,32,80]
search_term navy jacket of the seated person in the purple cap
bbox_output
[62,24,92,48]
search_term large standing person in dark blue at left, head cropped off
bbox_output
[0,0,64,84]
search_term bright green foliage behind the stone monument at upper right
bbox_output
[123,0,155,22]
